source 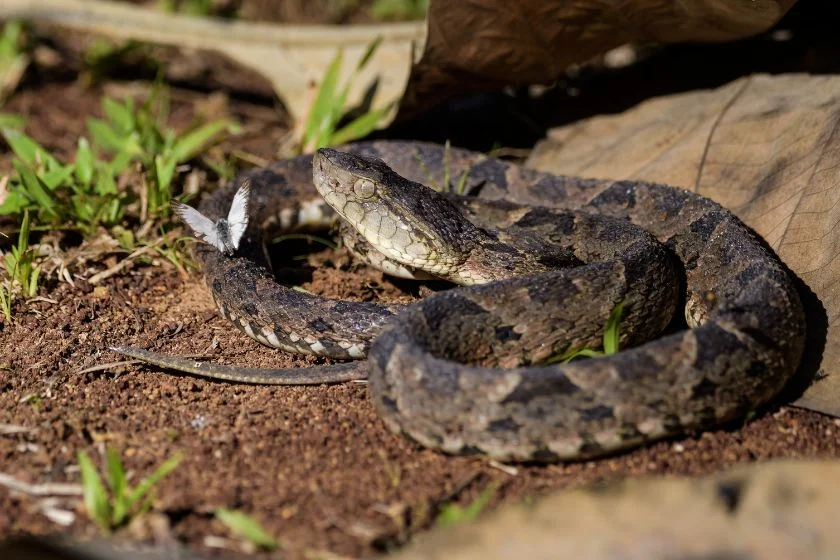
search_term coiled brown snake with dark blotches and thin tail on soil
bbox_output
[108,140,806,463]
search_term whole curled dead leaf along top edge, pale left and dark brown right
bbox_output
[6,0,796,126]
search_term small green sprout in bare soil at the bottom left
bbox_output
[77,447,181,531]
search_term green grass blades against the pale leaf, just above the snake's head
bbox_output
[299,37,393,152]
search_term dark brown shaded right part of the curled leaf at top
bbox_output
[400,0,796,117]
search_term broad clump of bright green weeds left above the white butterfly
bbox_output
[0,91,232,234]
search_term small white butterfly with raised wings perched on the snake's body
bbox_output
[171,181,251,256]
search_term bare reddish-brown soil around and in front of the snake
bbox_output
[0,50,840,558]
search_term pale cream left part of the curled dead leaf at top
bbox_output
[0,0,426,127]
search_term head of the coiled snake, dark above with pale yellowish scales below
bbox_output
[312,148,479,277]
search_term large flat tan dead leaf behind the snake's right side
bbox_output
[529,74,840,415]
